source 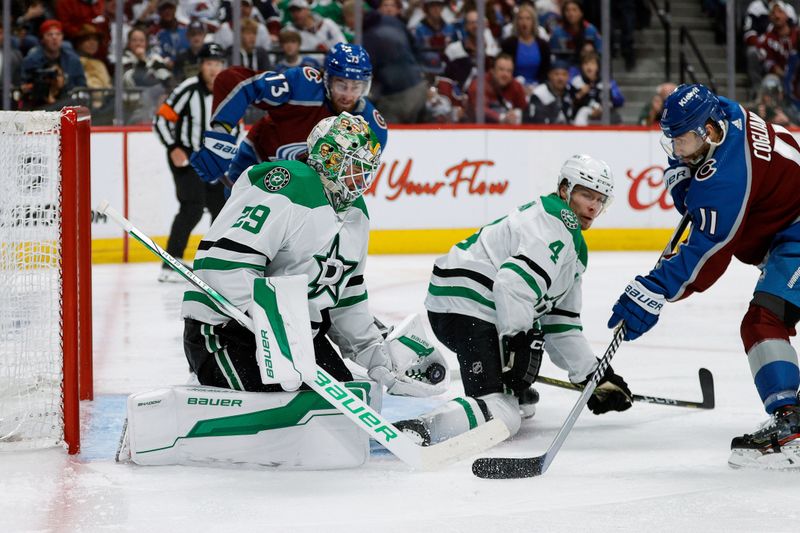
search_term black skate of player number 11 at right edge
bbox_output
[728,405,800,470]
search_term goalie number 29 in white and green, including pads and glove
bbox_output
[118,113,447,469]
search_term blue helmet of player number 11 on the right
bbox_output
[660,83,725,139]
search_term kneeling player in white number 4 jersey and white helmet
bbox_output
[397,155,631,444]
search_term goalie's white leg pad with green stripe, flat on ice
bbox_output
[127,382,380,470]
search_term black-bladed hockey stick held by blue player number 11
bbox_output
[472,213,690,479]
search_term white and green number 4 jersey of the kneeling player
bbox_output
[425,194,597,383]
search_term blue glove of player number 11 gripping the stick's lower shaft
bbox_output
[608,276,664,341]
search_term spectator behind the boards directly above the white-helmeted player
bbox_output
[569,49,625,126]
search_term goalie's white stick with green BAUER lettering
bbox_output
[97,201,508,470]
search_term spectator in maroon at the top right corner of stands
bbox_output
[758,0,798,85]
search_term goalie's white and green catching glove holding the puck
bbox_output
[354,315,450,397]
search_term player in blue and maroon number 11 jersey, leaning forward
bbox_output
[608,84,800,469]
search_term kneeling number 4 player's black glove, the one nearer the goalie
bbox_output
[502,329,544,392]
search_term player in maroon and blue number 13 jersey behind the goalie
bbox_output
[191,44,387,186]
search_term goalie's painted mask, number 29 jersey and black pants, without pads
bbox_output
[183,113,416,391]
